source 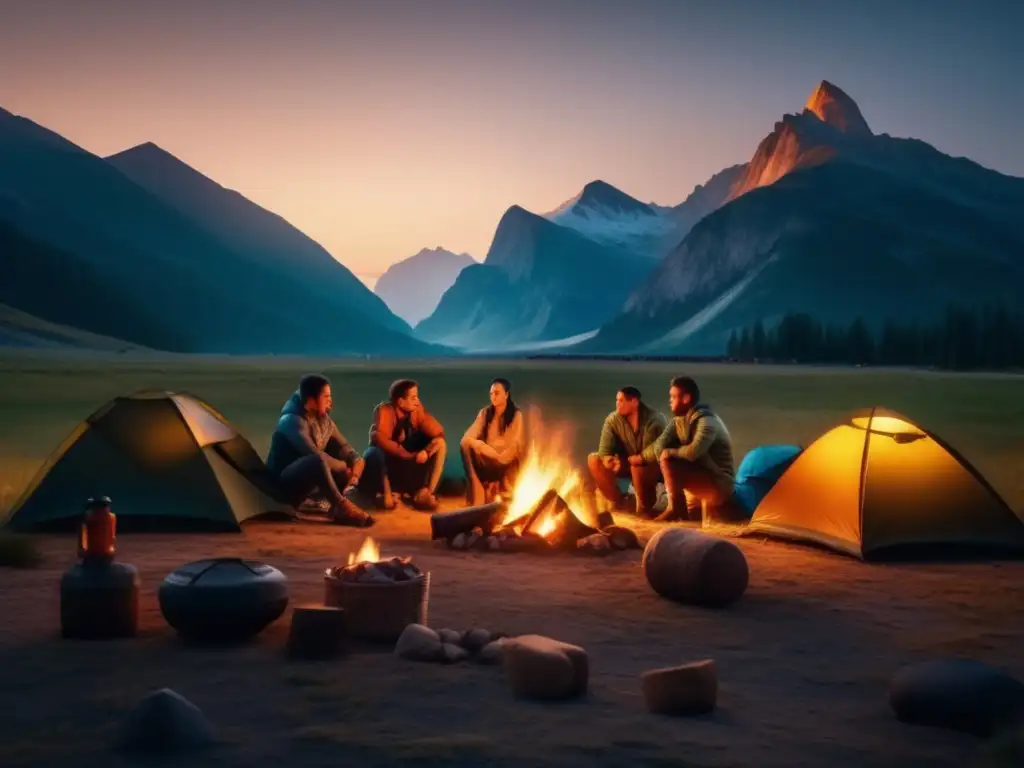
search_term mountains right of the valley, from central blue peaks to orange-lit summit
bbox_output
[417,81,1024,355]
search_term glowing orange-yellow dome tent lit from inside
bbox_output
[744,408,1024,560]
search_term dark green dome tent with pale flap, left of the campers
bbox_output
[5,391,294,531]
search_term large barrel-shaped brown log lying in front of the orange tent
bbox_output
[642,528,750,607]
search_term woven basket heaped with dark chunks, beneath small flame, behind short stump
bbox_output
[324,557,430,643]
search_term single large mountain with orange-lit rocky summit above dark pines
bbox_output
[574,81,1024,354]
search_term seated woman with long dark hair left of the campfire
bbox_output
[461,379,525,505]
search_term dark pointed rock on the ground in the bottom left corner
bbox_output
[121,688,214,755]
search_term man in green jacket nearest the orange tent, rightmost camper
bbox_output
[630,376,736,520]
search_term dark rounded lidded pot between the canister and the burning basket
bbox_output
[159,557,288,643]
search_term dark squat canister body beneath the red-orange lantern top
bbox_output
[60,561,139,640]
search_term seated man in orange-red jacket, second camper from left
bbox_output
[358,379,446,511]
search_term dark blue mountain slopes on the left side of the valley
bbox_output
[0,111,443,354]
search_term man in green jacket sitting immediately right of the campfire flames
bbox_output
[587,387,666,517]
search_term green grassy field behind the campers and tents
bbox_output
[0,355,1024,515]
